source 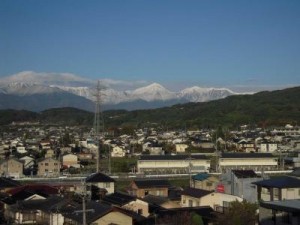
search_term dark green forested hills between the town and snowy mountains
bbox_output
[0,87,300,129]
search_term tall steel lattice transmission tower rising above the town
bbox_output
[93,80,104,173]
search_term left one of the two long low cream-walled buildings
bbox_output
[137,155,210,174]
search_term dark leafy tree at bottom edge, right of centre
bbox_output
[216,200,257,225]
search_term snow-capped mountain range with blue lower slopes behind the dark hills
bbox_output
[0,71,238,111]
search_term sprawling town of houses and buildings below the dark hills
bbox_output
[0,122,300,225]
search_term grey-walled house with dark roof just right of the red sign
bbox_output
[220,170,263,203]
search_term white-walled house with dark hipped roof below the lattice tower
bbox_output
[85,173,116,194]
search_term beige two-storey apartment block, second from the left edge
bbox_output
[37,158,61,177]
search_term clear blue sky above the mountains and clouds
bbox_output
[0,0,300,89]
